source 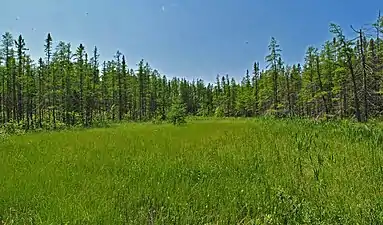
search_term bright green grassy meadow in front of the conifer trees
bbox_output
[0,119,383,224]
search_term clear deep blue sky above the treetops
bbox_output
[0,0,383,81]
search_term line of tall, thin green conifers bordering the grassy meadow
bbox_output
[0,15,383,130]
